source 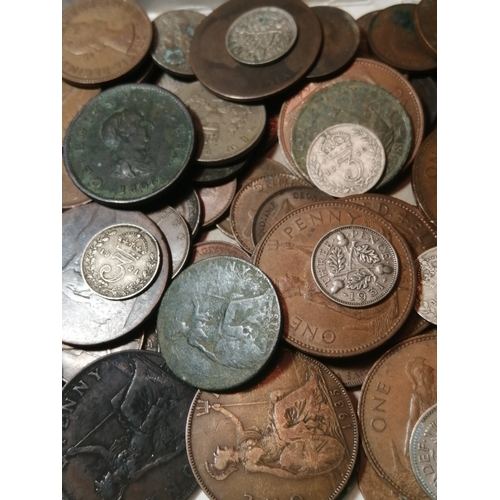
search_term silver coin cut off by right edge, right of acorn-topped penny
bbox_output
[415,247,437,325]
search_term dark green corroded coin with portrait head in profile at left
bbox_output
[64,84,195,205]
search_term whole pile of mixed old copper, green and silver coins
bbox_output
[62,0,437,500]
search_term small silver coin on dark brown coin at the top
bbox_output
[226,7,298,65]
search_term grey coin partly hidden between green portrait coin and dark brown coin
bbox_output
[177,82,266,165]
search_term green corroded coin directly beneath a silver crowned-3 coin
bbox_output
[291,80,412,189]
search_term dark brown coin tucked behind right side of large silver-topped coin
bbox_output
[306,6,360,80]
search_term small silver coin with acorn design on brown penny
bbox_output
[311,225,399,307]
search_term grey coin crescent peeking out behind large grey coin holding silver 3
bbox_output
[146,206,191,278]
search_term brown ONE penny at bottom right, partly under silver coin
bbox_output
[358,334,437,500]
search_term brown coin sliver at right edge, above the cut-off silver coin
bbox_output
[411,129,437,226]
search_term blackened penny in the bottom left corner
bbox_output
[62,350,196,500]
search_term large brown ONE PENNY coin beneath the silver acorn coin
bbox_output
[252,201,416,357]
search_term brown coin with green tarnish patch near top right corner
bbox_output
[368,3,437,71]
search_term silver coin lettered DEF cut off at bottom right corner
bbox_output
[410,404,437,500]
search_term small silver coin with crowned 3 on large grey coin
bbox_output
[82,224,160,300]
